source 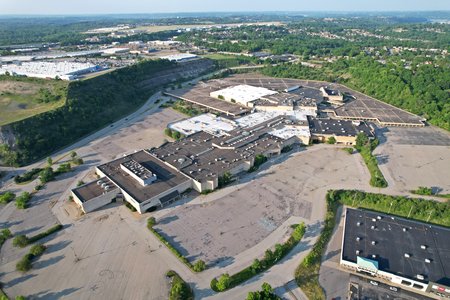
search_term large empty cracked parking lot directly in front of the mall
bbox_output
[155,147,369,264]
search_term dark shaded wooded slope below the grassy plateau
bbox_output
[0,60,185,165]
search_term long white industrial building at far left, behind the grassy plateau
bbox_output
[0,61,100,80]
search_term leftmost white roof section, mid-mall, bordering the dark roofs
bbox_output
[169,114,236,136]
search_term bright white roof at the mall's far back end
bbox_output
[210,84,278,105]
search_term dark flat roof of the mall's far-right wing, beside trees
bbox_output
[308,118,374,137]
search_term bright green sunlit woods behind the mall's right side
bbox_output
[263,54,450,130]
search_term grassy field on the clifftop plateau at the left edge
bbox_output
[0,76,67,126]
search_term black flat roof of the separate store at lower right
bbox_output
[342,208,450,286]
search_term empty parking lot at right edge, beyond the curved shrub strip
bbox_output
[374,127,450,193]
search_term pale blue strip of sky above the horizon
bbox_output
[0,0,450,15]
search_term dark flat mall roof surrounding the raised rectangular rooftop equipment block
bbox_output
[97,150,190,203]
